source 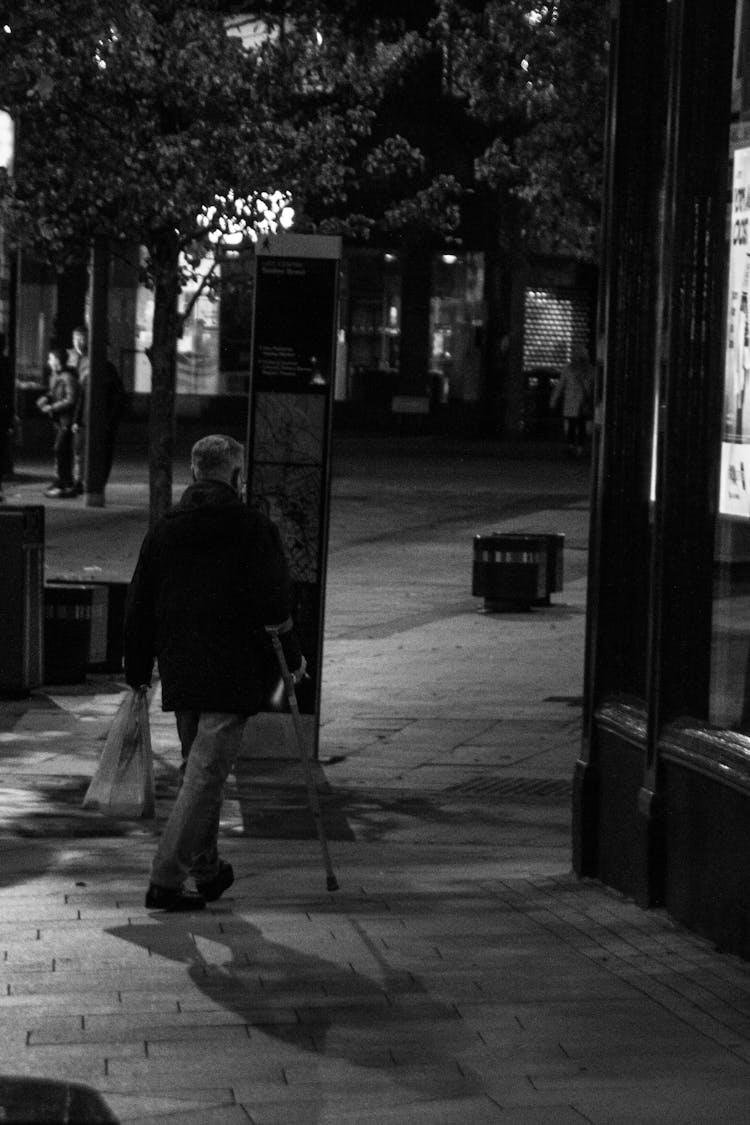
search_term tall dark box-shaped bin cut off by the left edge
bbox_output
[0,504,44,695]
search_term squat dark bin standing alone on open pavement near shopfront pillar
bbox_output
[471,532,564,612]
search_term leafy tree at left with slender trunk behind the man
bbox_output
[0,0,394,519]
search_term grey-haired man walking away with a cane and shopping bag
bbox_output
[125,434,306,910]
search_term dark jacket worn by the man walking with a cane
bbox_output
[125,480,301,714]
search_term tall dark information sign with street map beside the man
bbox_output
[247,234,341,756]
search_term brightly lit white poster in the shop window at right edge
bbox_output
[719,147,750,519]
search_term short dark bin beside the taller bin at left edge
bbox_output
[44,583,107,684]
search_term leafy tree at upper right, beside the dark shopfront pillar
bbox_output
[435,0,607,433]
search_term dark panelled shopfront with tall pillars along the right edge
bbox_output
[573,0,750,956]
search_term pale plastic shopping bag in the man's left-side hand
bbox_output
[83,690,155,818]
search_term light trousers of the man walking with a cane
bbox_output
[151,711,247,889]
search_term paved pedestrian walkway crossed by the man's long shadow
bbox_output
[0,448,750,1125]
